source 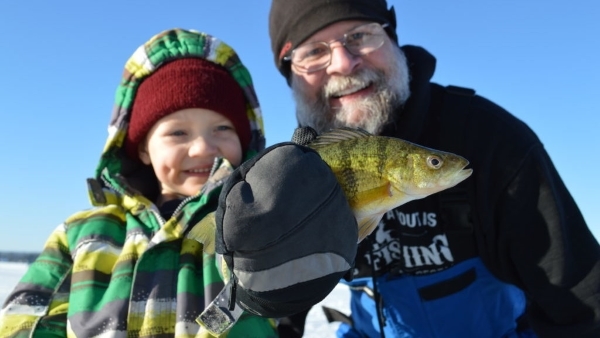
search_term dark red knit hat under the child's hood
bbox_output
[125,58,252,159]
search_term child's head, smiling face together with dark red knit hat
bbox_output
[125,58,251,211]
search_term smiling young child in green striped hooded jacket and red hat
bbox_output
[0,29,276,337]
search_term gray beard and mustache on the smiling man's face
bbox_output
[291,46,410,134]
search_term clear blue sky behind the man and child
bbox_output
[0,0,600,251]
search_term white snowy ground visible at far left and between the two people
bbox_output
[0,262,350,338]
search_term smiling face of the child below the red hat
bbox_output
[138,108,242,202]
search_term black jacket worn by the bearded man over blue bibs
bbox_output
[370,46,600,337]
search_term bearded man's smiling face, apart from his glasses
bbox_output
[291,21,410,134]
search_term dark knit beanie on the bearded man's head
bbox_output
[269,0,398,83]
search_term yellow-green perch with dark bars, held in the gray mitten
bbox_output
[308,128,473,242]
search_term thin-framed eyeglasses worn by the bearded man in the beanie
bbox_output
[283,22,388,73]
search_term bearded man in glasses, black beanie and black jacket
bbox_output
[269,0,600,338]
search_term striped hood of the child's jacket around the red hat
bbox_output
[88,28,265,205]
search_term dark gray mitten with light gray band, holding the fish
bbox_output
[215,138,358,317]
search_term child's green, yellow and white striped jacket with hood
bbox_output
[0,29,276,338]
